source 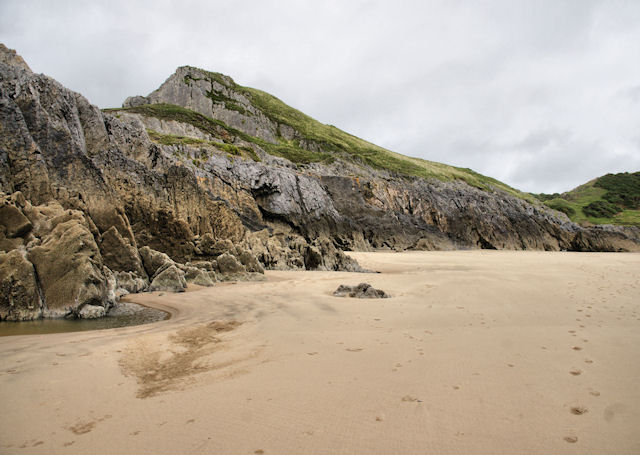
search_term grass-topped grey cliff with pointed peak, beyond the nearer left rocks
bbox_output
[113,67,640,251]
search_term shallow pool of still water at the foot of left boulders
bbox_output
[0,302,170,337]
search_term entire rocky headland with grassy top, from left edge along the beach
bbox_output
[0,45,640,320]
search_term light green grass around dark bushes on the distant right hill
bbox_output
[545,174,640,226]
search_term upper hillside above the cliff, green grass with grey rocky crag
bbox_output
[105,66,532,201]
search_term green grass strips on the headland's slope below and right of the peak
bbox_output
[105,68,535,202]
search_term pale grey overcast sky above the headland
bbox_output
[0,0,640,193]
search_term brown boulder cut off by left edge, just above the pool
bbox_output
[0,250,42,321]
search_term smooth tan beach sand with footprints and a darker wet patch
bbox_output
[0,251,640,454]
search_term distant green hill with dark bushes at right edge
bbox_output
[534,172,640,226]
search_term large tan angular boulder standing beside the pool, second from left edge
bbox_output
[27,214,107,317]
